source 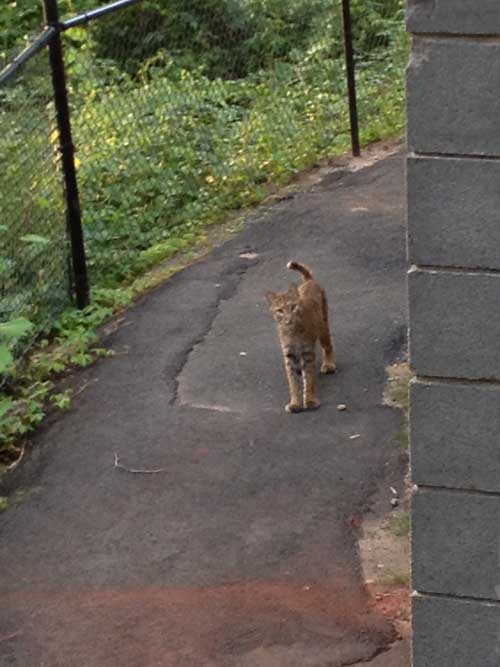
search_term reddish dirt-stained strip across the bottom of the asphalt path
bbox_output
[0,582,401,667]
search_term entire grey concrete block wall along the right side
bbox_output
[407,0,500,667]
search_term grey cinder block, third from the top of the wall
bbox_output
[407,155,500,269]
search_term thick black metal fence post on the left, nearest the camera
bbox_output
[43,0,89,308]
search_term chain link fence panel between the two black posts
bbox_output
[64,0,362,287]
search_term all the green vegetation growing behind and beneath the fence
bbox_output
[0,0,406,464]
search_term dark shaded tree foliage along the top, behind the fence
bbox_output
[0,0,402,78]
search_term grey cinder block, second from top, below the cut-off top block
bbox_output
[407,38,500,156]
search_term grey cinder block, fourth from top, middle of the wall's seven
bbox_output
[408,269,500,380]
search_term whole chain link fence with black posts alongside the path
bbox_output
[0,0,401,360]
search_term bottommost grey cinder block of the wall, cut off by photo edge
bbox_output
[413,595,500,667]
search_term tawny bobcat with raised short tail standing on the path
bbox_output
[266,262,336,412]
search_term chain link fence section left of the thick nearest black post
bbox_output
[0,39,71,352]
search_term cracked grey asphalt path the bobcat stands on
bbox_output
[0,155,406,667]
